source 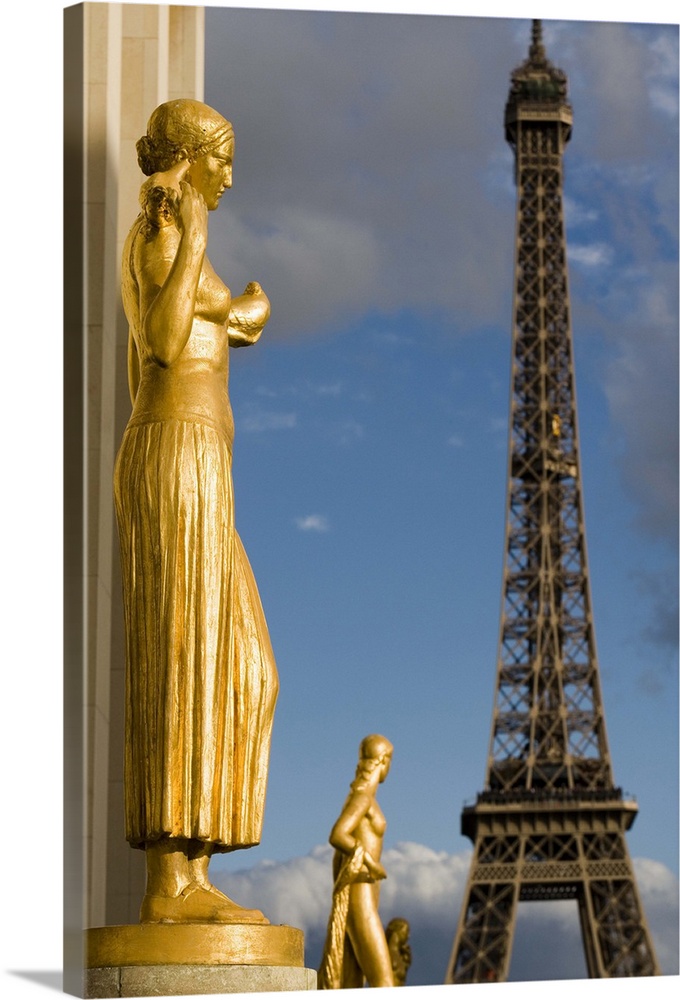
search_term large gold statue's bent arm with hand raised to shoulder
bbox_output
[137,181,208,368]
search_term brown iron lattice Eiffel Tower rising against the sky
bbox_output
[446,20,660,983]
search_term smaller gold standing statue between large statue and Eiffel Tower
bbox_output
[318,735,395,990]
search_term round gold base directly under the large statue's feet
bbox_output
[85,923,304,969]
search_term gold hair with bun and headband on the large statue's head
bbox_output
[137,98,234,177]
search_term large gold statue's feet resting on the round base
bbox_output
[139,882,269,924]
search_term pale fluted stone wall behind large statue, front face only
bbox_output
[74,3,204,926]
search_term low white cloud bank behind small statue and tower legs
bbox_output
[213,843,678,986]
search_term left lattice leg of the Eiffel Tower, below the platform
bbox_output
[446,867,518,983]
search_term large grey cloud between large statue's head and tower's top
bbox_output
[206,10,529,337]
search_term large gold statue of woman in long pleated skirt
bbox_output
[115,100,278,923]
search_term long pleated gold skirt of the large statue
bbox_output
[115,420,278,851]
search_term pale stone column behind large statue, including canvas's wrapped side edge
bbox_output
[64,3,204,992]
